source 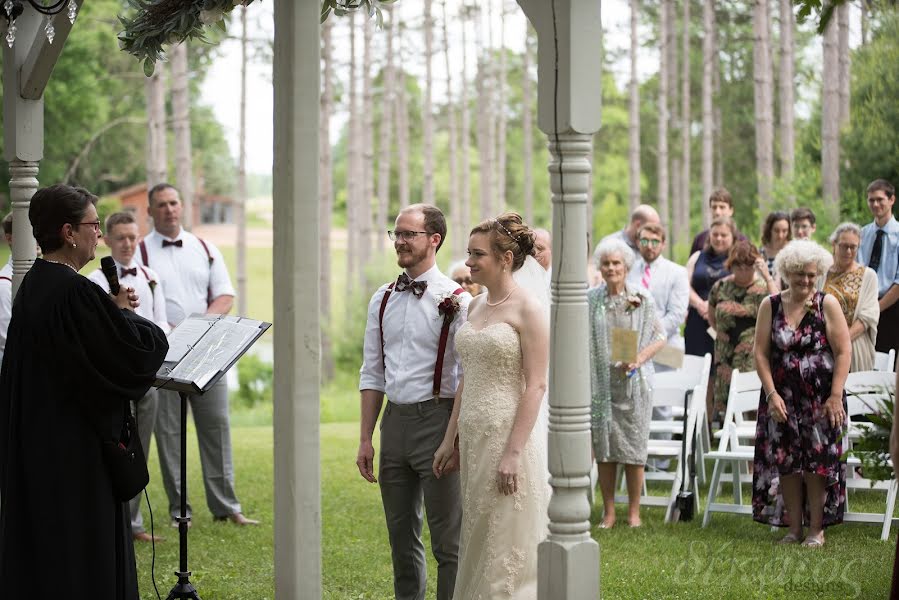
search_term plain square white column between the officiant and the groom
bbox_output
[273,0,322,600]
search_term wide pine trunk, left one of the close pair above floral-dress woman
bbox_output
[752,0,774,216]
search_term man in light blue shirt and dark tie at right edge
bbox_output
[859,179,899,352]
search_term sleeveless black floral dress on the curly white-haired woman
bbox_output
[752,292,846,527]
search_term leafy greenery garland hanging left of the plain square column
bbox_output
[119,0,253,77]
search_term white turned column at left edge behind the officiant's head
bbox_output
[0,7,43,297]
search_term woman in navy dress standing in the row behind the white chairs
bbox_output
[684,217,737,356]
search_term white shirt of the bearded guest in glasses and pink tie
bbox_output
[627,256,690,346]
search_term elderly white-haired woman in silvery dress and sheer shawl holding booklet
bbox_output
[587,239,665,529]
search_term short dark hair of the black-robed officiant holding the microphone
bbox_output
[28,184,97,254]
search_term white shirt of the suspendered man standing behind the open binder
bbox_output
[135,229,234,327]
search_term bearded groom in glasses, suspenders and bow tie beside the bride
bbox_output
[356,204,471,600]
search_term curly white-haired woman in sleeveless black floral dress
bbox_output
[752,240,851,547]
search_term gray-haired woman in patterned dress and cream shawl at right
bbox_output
[824,223,880,373]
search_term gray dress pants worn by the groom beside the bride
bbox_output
[378,399,462,600]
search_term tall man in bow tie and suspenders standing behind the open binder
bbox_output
[138,183,258,527]
